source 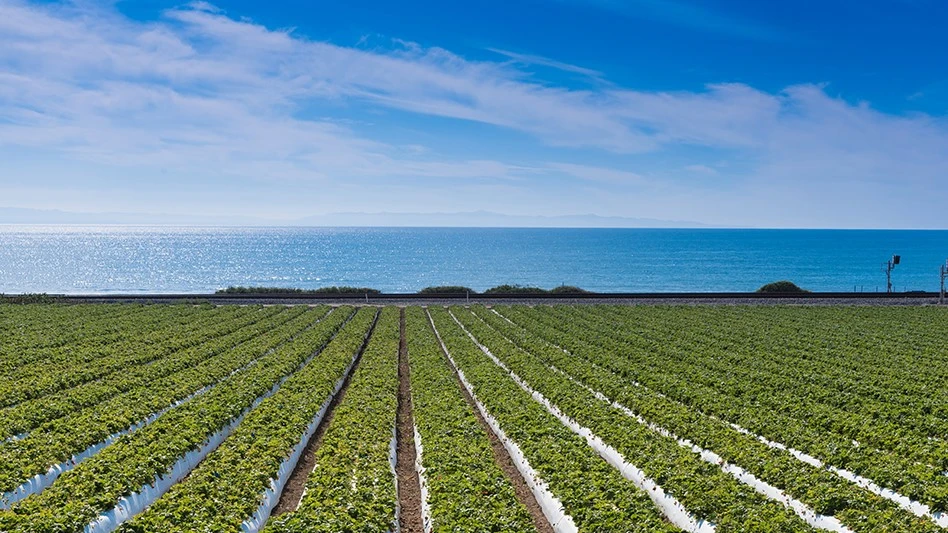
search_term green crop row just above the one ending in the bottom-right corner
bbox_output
[536,309,948,512]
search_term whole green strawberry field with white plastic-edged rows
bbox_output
[0,304,948,533]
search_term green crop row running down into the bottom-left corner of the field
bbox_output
[0,308,360,532]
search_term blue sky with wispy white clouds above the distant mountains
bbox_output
[0,0,948,228]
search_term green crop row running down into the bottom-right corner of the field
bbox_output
[486,308,939,533]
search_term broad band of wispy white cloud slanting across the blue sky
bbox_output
[0,1,948,225]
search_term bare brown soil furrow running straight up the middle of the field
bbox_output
[395,308,425,533]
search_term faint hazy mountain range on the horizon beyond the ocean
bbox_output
[0,207,712,228]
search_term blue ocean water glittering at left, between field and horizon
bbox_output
[0,225,948,294]
